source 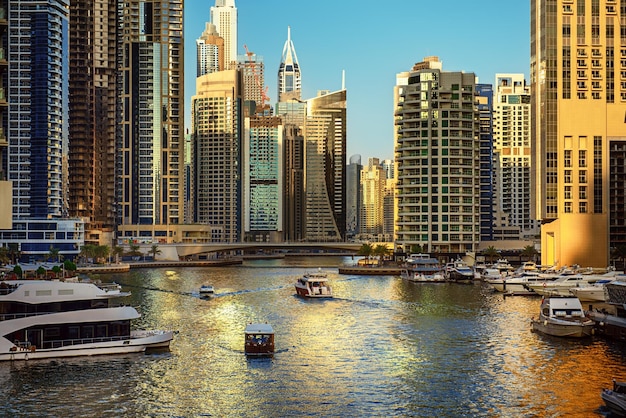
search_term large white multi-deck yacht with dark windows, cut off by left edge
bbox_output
[0,280,174,360]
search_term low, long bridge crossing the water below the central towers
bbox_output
[140,242,393,260]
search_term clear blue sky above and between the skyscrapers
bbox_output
[184,0,530,164]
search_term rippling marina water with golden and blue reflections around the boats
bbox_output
[0,257,626,417]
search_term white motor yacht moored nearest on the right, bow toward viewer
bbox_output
[531,296,595,338]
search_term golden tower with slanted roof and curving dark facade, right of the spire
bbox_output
[304,88,347,242]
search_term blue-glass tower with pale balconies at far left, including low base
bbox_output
[0,0,84,262]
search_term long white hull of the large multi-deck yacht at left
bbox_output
[0,331,174,361]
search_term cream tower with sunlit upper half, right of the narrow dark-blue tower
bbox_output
[493,74,539,239]
